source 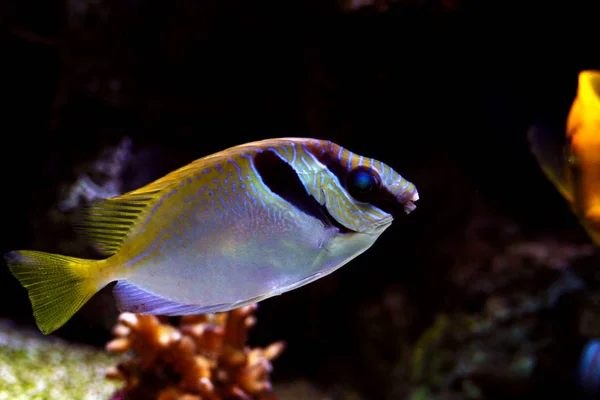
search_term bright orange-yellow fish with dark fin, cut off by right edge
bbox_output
[527,70,600,246]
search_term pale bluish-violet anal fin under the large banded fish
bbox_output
[113,281,229,316]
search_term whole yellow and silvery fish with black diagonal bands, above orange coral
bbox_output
[4,138,419,334]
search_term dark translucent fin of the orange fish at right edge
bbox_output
[527,125,573,204]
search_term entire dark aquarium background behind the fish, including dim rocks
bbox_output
[0,0,600,399]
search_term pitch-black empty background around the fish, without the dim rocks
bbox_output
[0,0,600,398]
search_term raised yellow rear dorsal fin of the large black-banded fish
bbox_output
[75,192,157,256]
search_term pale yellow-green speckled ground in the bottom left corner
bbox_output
[0,321,117,400]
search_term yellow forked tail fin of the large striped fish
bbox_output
[4,250,100,335]
